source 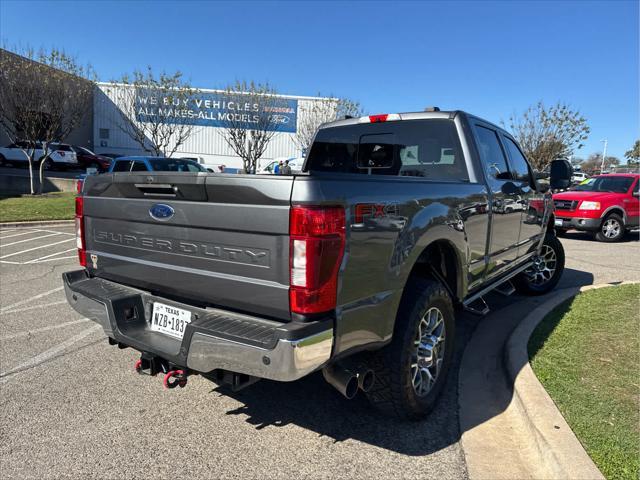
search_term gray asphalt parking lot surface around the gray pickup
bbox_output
[0,226,640,478]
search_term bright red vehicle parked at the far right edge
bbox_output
[553,173,640,242]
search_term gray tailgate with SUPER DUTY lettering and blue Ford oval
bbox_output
[84,172,294,320]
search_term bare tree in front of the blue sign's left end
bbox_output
[111,67,199,157]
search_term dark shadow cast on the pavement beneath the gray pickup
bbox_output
[212,269,593,456]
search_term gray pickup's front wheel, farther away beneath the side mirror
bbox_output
[513,234,564,295]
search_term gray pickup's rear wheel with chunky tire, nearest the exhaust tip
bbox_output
[366,278,455,420]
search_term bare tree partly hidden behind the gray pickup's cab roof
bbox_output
[293,94,363,151]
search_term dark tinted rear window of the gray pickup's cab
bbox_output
[308,119,469,181]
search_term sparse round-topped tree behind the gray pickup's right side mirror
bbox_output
[503,102,590,170]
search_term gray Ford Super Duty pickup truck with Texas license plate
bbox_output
[63,109,571,418]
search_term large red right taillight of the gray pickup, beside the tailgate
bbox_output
[289,206,345,314]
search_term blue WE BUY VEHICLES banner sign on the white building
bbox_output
[136,93,298,133]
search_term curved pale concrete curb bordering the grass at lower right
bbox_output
[504,282,637,479]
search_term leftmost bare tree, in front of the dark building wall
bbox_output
[0,48,96,195]
